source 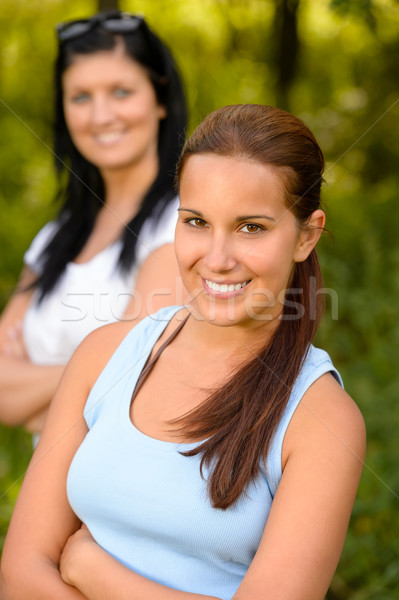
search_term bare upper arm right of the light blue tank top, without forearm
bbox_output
[234,374,366,600]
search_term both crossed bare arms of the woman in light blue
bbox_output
[1,310,365,600]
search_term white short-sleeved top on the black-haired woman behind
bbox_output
[24,198,178,365]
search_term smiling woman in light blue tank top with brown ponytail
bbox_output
[2,105,365,600]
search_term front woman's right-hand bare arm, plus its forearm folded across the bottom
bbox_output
[55,375,365,600]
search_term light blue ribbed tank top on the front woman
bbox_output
[67,306,342,600]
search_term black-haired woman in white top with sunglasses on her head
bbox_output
[0,11,186,432]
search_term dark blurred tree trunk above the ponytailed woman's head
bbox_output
[274,0,300,110]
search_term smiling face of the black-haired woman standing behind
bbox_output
[62,46,166,172]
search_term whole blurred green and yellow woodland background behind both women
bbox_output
[0,0,399,600]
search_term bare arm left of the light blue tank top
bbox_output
[0,323,132,600]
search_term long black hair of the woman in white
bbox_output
[34,15,187,300]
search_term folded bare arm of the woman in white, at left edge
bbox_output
[0,269,64,426]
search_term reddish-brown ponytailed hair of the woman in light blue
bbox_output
[172,104,324,509]
